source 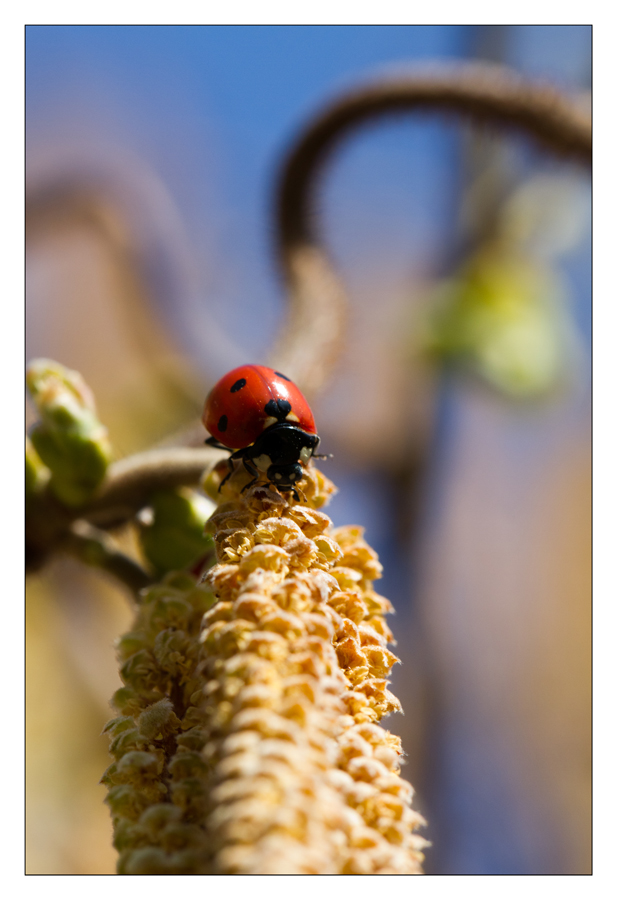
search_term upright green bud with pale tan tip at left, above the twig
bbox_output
[26,359,111,506]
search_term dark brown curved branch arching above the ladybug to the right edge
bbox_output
[270,63,591,394]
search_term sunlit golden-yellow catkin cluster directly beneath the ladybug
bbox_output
[200,467,426,874]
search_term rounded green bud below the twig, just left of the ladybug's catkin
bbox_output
[140,488,214,575]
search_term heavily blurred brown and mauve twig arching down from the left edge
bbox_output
[26,173,201,412]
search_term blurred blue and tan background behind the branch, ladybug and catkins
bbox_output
[26,25,591,874]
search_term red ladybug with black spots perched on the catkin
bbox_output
[202,366,326,500]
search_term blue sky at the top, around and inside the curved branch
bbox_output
[26,25,590,355]
